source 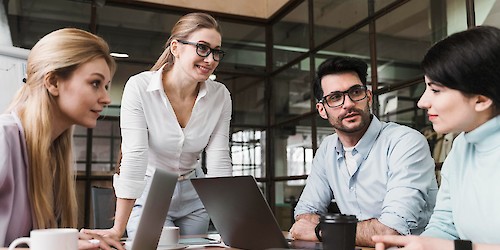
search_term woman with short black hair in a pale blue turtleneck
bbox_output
[373,26,500,250]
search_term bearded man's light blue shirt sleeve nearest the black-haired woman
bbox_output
[379,131,437,235]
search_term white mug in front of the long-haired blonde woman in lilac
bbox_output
[9,228,78,250]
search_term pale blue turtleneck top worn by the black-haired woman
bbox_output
[422,116,500,244]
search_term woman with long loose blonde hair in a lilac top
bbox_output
[0,28,123,249]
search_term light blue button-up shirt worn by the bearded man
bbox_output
[295,116,437,235]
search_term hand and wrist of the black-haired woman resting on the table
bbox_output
[372,235,454,250]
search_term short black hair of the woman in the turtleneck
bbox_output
[421,26,500,107]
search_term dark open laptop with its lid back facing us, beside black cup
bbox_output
[191,176,290,249]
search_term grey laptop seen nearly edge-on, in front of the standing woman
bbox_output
[125,168,178,250]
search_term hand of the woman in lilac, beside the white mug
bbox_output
[78,228,125,250]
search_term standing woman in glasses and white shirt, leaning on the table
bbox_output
[84,13,232,238]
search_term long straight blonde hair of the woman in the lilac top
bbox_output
[8,28,116,228]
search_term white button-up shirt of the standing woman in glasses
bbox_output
[113,68,232,199]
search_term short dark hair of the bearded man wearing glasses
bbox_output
[314,56,368,101]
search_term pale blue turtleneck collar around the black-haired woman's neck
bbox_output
[464,115,500,152]
